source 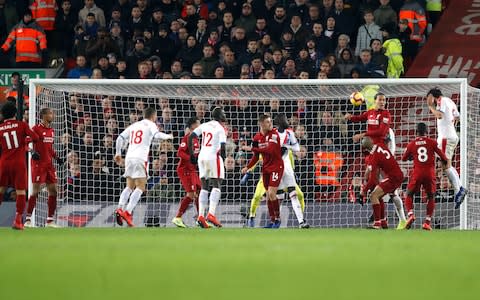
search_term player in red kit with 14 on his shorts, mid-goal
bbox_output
[242,114,284,228]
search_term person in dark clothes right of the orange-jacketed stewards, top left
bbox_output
[54,0,78,57]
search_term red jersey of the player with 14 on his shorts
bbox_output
[248,128,283,172]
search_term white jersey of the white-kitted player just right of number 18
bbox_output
[193,120,227,160]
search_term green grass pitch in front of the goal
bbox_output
[0,228,480,300]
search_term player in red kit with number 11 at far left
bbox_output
[0,102,40,230]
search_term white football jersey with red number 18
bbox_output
[120,119,173,162]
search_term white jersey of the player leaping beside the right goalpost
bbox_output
[437,96,460,139]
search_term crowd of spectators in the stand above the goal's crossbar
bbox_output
[0,0,441,79]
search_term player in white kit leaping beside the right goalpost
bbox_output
[427,88,467,208]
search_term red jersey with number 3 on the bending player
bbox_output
[365,145,403,191]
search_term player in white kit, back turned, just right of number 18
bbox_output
[188,107,227,228]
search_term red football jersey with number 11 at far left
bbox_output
[0,120,38,163]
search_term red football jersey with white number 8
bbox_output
[402,136,447,170]
